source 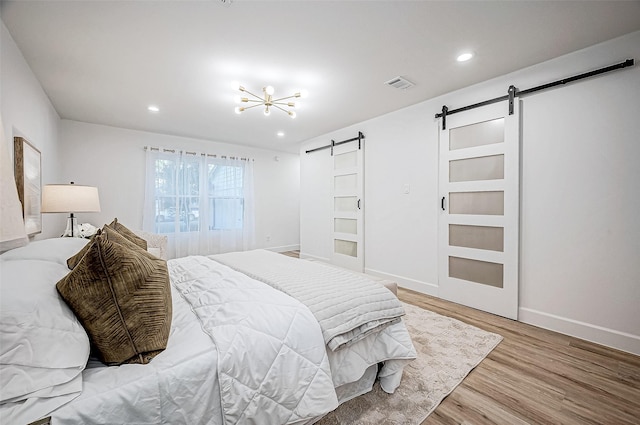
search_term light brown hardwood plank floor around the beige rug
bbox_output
[287,251,640,425]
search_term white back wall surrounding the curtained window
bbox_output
[58,120,300,250]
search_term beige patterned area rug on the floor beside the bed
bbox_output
[317,303,502,425]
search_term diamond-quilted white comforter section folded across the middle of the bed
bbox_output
[168,256,338,425]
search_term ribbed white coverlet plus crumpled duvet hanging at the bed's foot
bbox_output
[208,250,416,394]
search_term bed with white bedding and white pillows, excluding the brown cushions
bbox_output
[0,230,416,425]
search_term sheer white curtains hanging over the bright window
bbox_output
[143,148,255,258]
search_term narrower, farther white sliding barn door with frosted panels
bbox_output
[331,142,364,272]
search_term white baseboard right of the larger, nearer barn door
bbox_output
[518,307,640,356]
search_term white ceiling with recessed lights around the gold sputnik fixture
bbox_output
[0,0,640,152]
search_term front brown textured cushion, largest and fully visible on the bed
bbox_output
[56,234,172,365]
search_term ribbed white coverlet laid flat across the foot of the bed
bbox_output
[210,250,404,351]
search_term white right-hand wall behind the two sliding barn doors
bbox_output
[300,32,640,354]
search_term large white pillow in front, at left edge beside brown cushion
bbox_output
[0,256,89,403]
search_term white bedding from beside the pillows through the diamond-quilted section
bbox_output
[47,253,338,425]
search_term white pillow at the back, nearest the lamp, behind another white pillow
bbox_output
[0,238,89,264]
